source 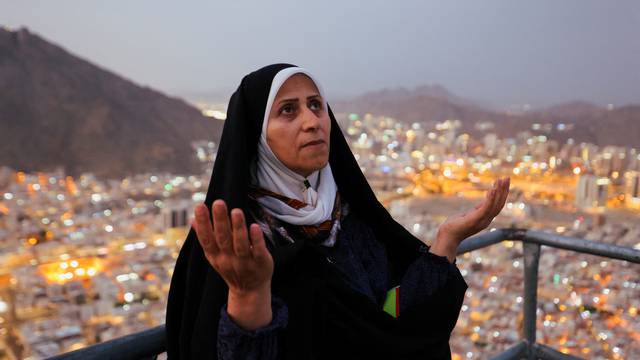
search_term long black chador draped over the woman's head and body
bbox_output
[166,64,467,359]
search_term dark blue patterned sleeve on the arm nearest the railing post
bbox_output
[399,249,458,313]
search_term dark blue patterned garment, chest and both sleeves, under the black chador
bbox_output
[218,210,458,360]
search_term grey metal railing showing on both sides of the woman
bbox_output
[51,228,640,360]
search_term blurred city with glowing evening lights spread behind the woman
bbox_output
[0,104,640,359]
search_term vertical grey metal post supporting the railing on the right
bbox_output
[522,241,540,360]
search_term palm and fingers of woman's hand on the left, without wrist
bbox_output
[192,199,273,297]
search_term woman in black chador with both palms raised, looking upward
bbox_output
[166,64,509,359]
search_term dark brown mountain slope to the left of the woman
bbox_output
[0,28,223,178]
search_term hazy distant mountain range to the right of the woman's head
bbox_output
[331,86,640,147]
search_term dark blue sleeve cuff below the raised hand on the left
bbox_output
[217,296,289,360]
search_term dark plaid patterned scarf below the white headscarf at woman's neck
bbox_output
[249,186,348,247]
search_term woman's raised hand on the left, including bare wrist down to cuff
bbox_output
[191,199,273,330]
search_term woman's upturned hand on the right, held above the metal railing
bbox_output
[433,177,511,257]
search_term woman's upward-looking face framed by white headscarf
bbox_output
[267,73,331,177]
